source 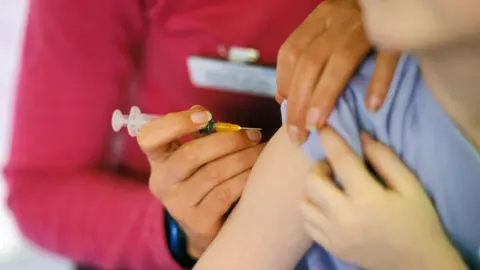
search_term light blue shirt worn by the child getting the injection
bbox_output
[282,56,480,270]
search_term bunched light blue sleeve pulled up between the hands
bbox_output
[281,56,418,161]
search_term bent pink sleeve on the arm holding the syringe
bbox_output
[5,0,178,270]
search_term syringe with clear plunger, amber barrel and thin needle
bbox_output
[112,106,261,137]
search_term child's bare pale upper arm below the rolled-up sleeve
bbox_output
[195,127,312,270]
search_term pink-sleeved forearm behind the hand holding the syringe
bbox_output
[6,166,178,269]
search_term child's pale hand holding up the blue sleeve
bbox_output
[301,128,467,270]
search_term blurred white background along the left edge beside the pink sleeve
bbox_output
[0,0,72,270]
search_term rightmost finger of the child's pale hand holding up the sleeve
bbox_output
[360,132,423,194]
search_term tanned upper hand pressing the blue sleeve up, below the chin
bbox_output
[276,0,399,143]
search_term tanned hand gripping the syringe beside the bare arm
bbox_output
[137,107,263,258]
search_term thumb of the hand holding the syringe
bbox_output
[137,106,212,154]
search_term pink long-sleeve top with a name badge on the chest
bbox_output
[5,0,319,270]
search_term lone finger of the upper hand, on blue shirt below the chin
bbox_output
[366,51,400,112]
